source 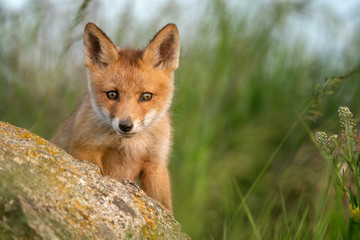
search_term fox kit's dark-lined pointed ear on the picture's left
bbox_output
[84,22,118,70]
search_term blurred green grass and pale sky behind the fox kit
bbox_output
[0,0,360,239]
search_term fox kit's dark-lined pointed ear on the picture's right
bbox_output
[143,23,180,71]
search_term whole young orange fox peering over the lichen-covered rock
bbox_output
[52,23,180,211]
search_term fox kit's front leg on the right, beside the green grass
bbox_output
[140,163,172,211]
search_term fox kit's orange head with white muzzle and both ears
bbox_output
[84,23,180,137]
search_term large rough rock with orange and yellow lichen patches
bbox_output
[0,122,189,239]
